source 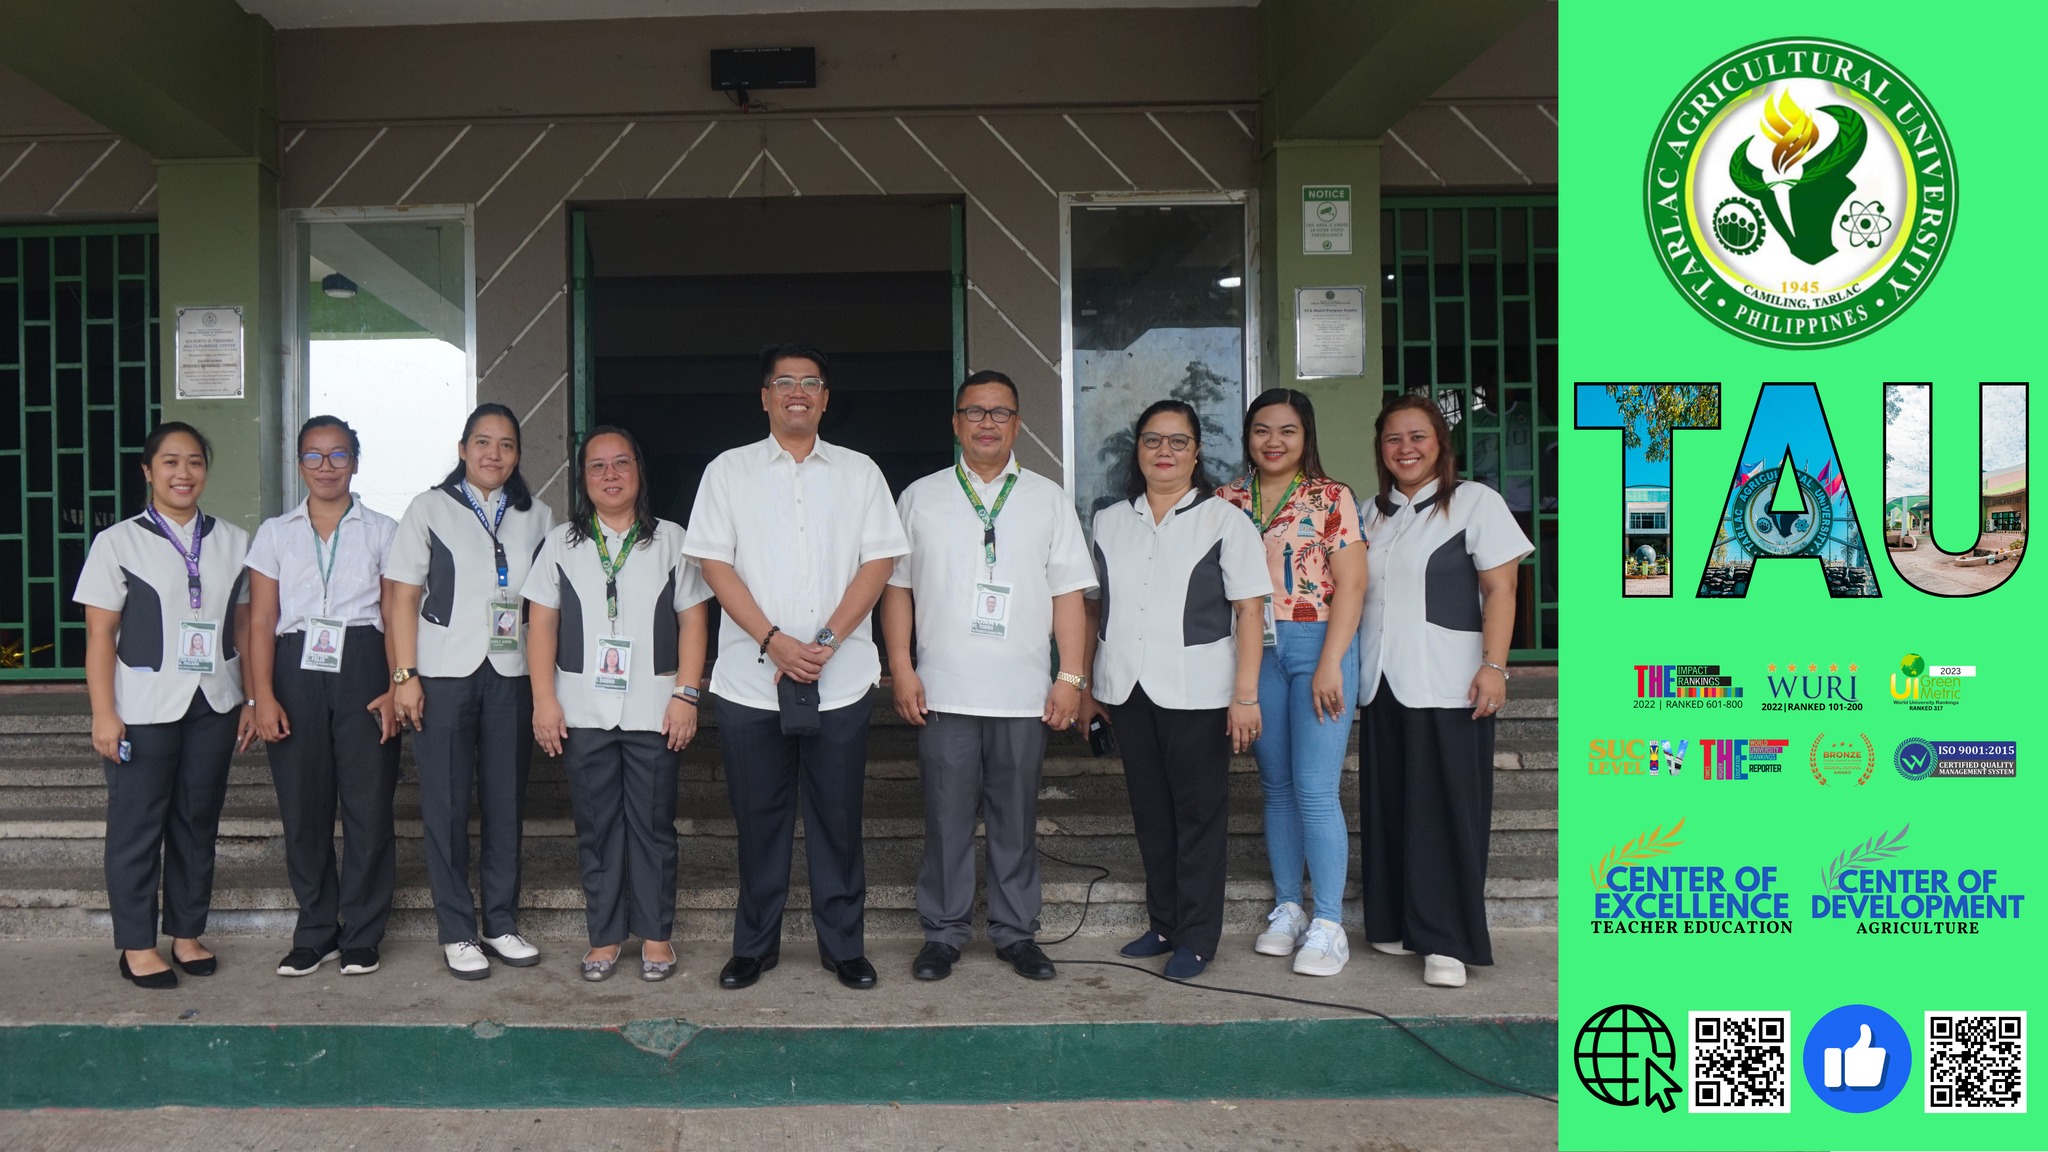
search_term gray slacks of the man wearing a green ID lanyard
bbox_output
[918,711,1047,947]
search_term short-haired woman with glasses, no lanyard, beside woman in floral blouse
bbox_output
[1079,400,1272,980]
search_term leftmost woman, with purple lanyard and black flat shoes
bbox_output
[74,422,256,988]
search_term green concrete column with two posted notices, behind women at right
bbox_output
[1260,139,1384,494]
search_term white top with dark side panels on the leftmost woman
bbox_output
[72,512,250,724]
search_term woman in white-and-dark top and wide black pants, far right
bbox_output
[1358,392,1532,988]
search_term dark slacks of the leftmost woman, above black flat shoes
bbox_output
[106,691,236,949]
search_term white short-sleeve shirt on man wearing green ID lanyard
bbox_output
[889,455,1096,717]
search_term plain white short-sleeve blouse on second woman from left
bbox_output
[244,500,397,635]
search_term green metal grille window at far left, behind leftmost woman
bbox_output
[0,223,158,681]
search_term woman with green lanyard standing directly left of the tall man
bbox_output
[524,426,711,982]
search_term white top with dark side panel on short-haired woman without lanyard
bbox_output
[1087,488,1274,709]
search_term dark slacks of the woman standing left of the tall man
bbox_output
[561,728,676,947]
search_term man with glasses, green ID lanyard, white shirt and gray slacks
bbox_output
[883,371,1096,980]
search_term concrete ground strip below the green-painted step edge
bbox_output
[0,1097,1556,1152]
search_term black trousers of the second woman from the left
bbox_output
[268,625,399,951]
